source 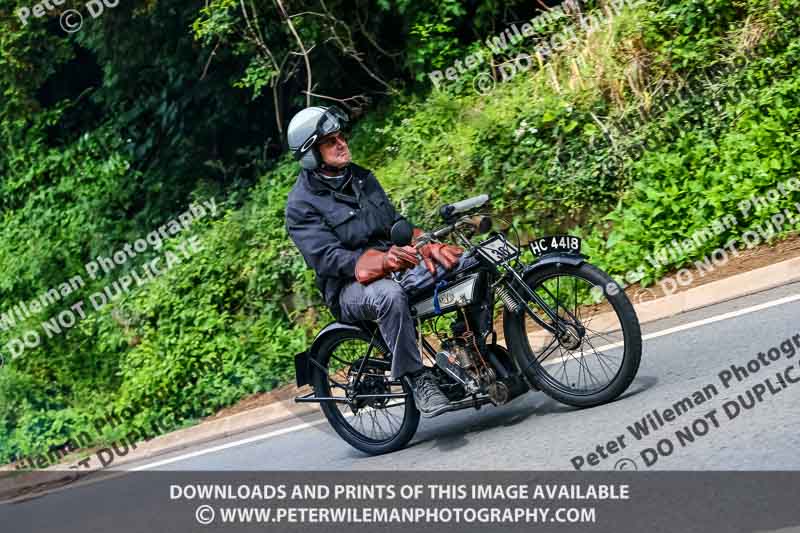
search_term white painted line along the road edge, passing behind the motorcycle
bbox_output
[128,294,800,472]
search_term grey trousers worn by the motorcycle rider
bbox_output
[339,256,475,379]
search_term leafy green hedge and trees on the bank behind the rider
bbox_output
[0,0,800,461]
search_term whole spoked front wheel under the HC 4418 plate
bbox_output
[503,263,642,407]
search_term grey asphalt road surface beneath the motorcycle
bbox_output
[115,278,800,471]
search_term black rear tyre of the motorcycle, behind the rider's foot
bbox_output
[311,330,420,455]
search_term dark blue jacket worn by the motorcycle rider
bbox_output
[286,164,402,318]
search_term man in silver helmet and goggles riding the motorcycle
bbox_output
[286,106,464,417]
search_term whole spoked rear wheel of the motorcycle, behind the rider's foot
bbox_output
[312,330,420,455]
